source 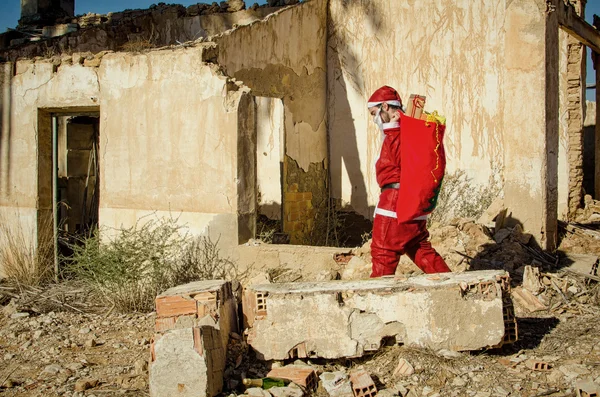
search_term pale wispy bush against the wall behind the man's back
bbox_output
[429,170,501,225]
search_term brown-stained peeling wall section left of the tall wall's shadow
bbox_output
[212,0,327,243]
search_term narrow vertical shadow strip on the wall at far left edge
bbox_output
[0,63,14,195]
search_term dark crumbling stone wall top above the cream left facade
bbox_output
[0,4,278,60]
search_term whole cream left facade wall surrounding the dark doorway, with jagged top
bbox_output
[0,44,248,268]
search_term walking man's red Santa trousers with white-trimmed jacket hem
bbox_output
[371,189,450,277]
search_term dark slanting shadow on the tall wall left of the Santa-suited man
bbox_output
[327,0,382,217]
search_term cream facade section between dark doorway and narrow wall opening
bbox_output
[98,47,244,246]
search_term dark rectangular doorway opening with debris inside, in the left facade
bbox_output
[37,108,100,275]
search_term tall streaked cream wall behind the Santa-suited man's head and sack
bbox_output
[327,0,506,217]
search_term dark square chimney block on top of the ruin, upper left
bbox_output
[19,0,75,26]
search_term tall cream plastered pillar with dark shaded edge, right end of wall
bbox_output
[504,0,559,249]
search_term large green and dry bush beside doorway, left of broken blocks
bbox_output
[65,217,234,312]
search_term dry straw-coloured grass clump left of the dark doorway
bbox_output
[0,212,54,286]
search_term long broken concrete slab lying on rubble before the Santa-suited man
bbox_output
[244,271,517,360]
